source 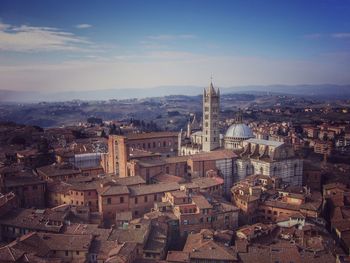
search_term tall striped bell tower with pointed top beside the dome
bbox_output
[202,82,220,152]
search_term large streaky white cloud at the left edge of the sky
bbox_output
[0,23,92,52]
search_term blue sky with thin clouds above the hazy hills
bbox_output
[0,0,350,91]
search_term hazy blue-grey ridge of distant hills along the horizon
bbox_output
[0,84,350,103]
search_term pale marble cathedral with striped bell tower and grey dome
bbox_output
[178,82,303,188]
